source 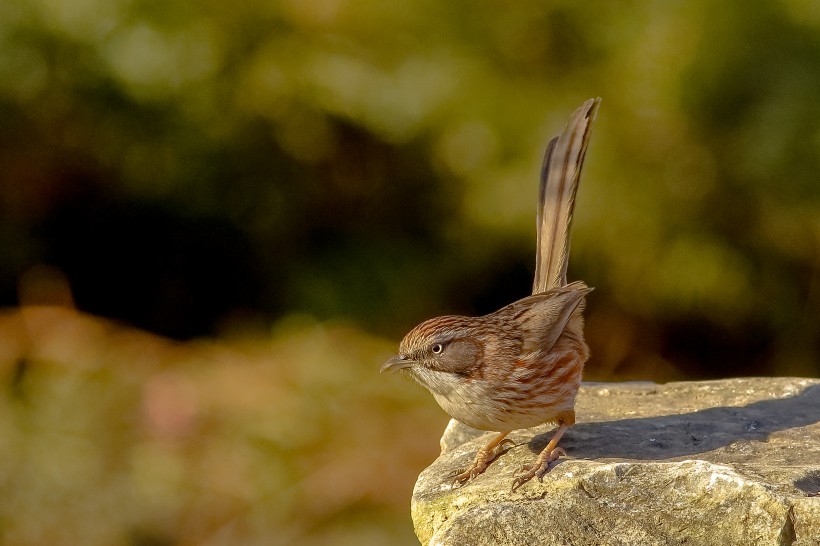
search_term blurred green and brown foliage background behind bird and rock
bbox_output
[0,0,820,545]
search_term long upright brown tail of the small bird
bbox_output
[532,98,601,294]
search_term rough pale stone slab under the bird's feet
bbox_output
[412,378,820,546]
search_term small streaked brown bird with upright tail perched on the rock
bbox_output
[381,99,601,489]
